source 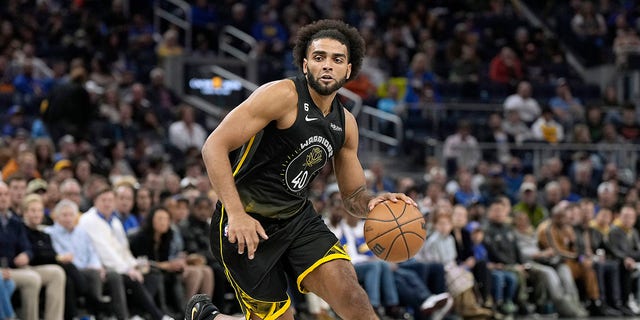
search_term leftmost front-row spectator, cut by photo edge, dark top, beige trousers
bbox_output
[0,182,65,320]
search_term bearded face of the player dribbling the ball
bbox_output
[303,38,351,95]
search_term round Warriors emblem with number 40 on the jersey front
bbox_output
[283,136,333,193]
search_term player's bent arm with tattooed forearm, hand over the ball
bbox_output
[333,110,416,217]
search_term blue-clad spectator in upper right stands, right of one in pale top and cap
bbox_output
[549,78,585,128]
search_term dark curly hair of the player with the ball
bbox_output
[293,20,365,80]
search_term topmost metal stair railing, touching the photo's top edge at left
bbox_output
[153,0,193,52]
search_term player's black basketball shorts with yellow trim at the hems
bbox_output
[211,202,349,320]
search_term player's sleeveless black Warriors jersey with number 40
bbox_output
[233,76,345,219]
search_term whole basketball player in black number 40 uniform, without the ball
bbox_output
[185,20,415,320]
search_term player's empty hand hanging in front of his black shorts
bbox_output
[227,213,269,259]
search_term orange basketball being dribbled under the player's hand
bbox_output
[364,200,427,262]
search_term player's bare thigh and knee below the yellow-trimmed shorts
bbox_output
[302,259,378,320]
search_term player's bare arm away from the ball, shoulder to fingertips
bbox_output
[202,80,297,259]
